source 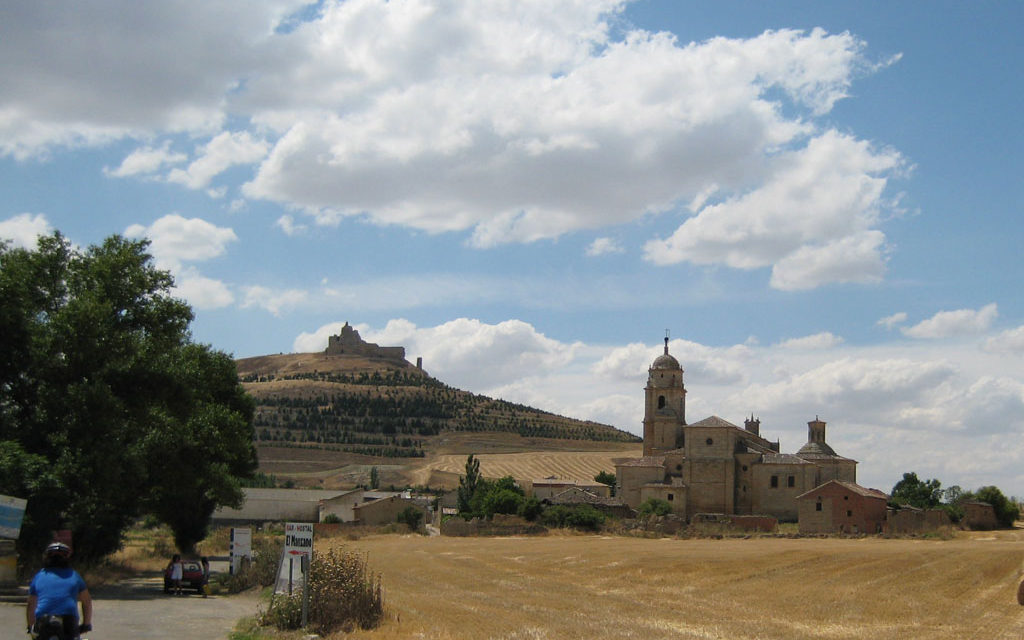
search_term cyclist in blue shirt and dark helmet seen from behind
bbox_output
[25,543,92,638]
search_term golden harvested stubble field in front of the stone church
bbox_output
[317,530,1024,640]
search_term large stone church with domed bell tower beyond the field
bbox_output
[615,338,857,520]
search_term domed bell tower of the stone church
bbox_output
[643,336,686,456]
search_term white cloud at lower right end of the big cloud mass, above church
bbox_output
[645,131,902,290]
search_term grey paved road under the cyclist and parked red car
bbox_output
[0,574,258,640]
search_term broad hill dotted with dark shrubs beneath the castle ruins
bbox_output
[236,353,640,488]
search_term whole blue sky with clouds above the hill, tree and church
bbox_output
[0,0,1024,496]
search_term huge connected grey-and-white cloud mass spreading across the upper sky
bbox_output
[0,0,903,290]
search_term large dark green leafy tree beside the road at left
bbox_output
[0,233,256,559]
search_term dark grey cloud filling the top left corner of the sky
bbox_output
[0,0,306,158]
